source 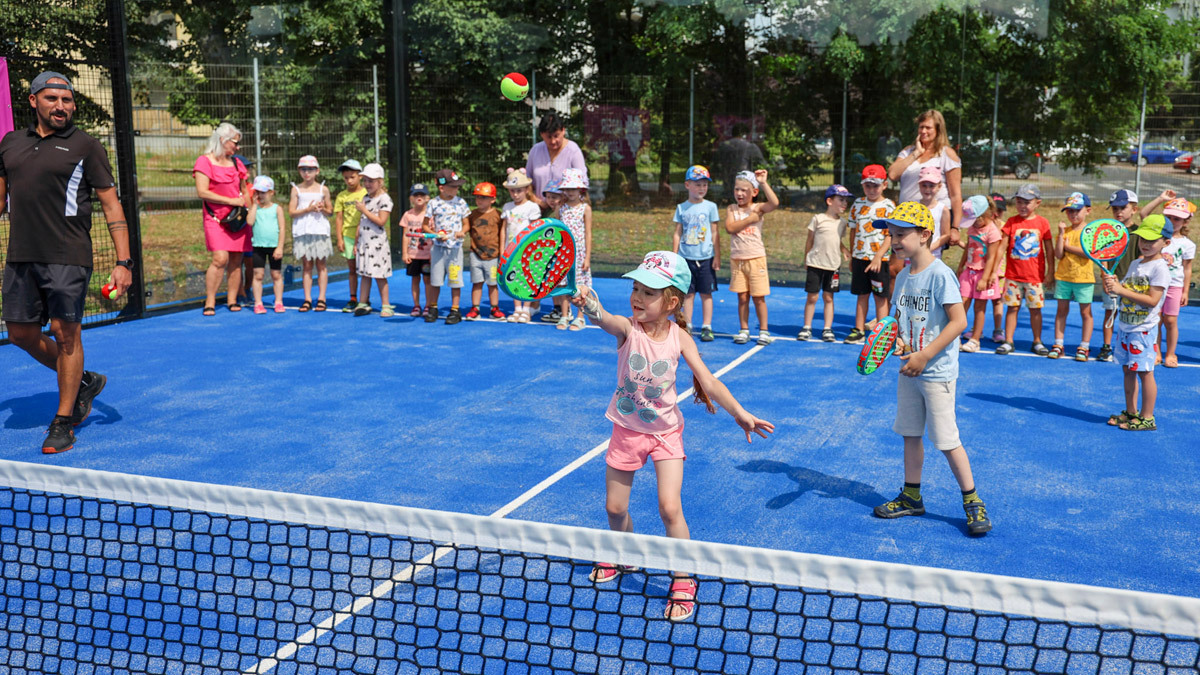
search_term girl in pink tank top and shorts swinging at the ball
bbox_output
[571,251,775,621]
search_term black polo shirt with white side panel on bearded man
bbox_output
[0,125,116,268]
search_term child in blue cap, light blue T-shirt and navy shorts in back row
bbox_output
[672,165,721,342]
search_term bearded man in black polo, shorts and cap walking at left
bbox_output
[0,72,133,453]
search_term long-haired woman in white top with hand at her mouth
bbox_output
[888,110,962,234]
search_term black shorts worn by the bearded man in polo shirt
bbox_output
[0,263,91,325]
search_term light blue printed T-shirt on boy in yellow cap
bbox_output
[892,258,962,382]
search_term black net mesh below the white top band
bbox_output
[0,488,1200,674]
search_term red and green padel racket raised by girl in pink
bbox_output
[497,217,577,303]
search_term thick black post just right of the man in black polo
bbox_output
[107,0,146,317]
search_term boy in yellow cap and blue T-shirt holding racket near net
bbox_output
[871,202,991,536]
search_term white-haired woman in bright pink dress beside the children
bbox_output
[192,123,252,316]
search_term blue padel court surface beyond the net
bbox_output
[7,267,1200,596]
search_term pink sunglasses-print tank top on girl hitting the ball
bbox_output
[605,318,683,434]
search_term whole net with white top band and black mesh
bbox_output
[0,461,1200,674]
